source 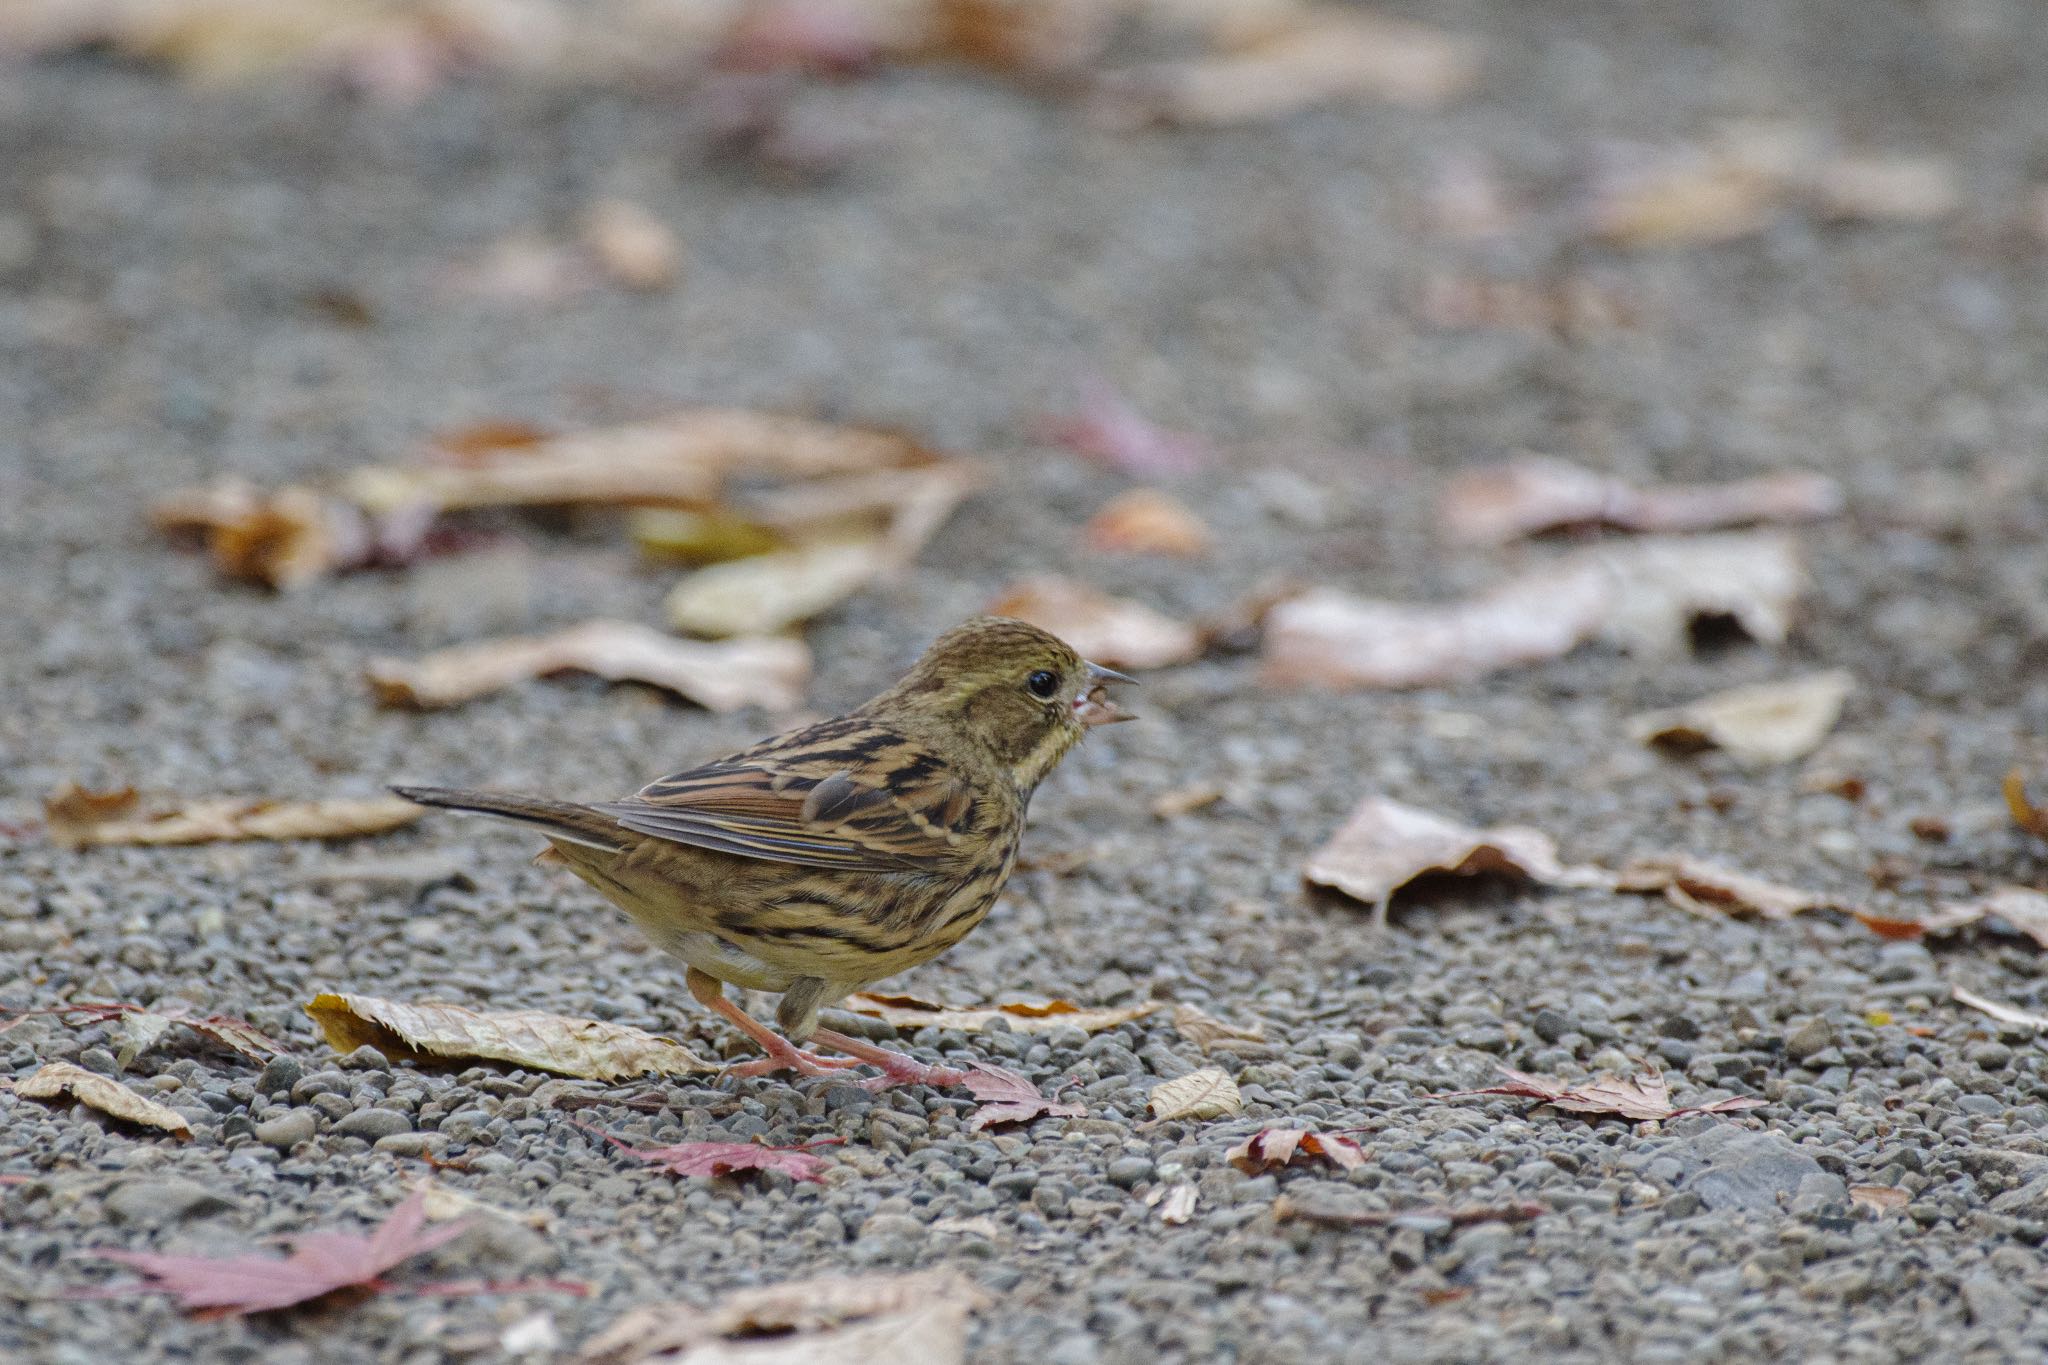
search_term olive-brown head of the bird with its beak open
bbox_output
[868,616,1135,792]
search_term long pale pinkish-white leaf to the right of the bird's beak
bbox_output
[1264,532,1804,688]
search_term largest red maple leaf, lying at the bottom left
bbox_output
[86,1191,467,1318]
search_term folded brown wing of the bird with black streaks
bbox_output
[596,737,983,872]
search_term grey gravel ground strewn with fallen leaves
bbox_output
[12,0,2048,1365]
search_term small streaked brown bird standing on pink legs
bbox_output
[391,616,1133,1089]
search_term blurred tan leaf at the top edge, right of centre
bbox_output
[1100,4,1479,127]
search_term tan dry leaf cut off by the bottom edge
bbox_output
[578,1271,989,1365]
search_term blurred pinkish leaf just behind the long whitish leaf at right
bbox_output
[1438,456,1843,544]
